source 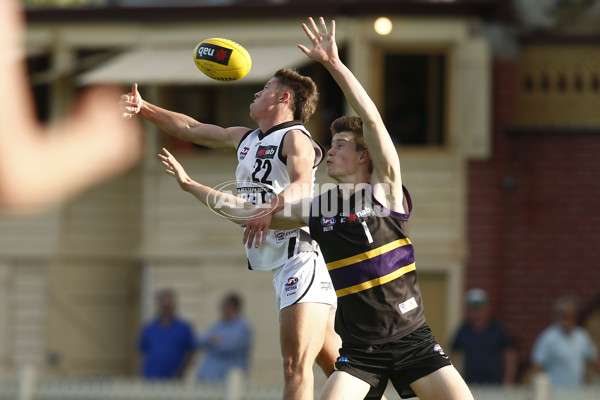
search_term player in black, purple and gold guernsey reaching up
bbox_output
[161,18,473,400]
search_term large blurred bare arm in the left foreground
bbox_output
[0,0,142,212]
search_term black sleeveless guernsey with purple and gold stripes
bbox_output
[309,185,425,345]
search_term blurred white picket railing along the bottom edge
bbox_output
[0,369,600,400]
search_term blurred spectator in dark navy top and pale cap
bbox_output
[452,288,518,385]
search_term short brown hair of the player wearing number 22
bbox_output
[274,68,319,124]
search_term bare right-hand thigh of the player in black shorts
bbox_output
[410,365,473,400]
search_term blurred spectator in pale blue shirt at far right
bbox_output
[531,296,600,388]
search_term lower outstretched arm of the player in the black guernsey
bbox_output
[158,149,310,229]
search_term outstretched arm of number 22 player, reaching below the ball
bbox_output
[119,83,250,150]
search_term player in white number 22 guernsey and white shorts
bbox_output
[120,69,341,399]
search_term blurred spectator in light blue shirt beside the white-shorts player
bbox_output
[197,293,252,382]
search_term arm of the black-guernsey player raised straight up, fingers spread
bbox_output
[298,17,403,211]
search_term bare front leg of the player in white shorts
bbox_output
[280,303,331,400]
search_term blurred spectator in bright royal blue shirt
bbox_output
[139,290,194,379]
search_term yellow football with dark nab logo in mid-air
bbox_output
[194,38,252,82]
